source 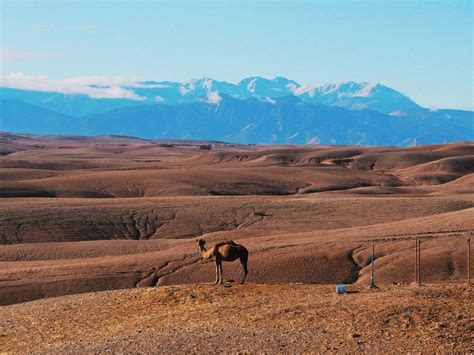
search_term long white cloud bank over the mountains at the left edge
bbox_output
[0,73,145,100]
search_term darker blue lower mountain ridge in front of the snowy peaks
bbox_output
[0,95,473,146]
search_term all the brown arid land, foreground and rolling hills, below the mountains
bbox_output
[0,133,474,352]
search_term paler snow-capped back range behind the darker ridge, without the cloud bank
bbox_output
[0,76,421,117]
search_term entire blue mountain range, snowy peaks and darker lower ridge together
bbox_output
[0,77,474,145]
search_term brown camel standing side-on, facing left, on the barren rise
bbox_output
[197,239,249,284]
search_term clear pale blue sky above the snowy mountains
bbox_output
[0,0,474,109]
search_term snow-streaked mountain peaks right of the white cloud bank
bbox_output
[129,76,419,112]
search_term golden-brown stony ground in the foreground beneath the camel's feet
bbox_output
[0,284,474,353]
